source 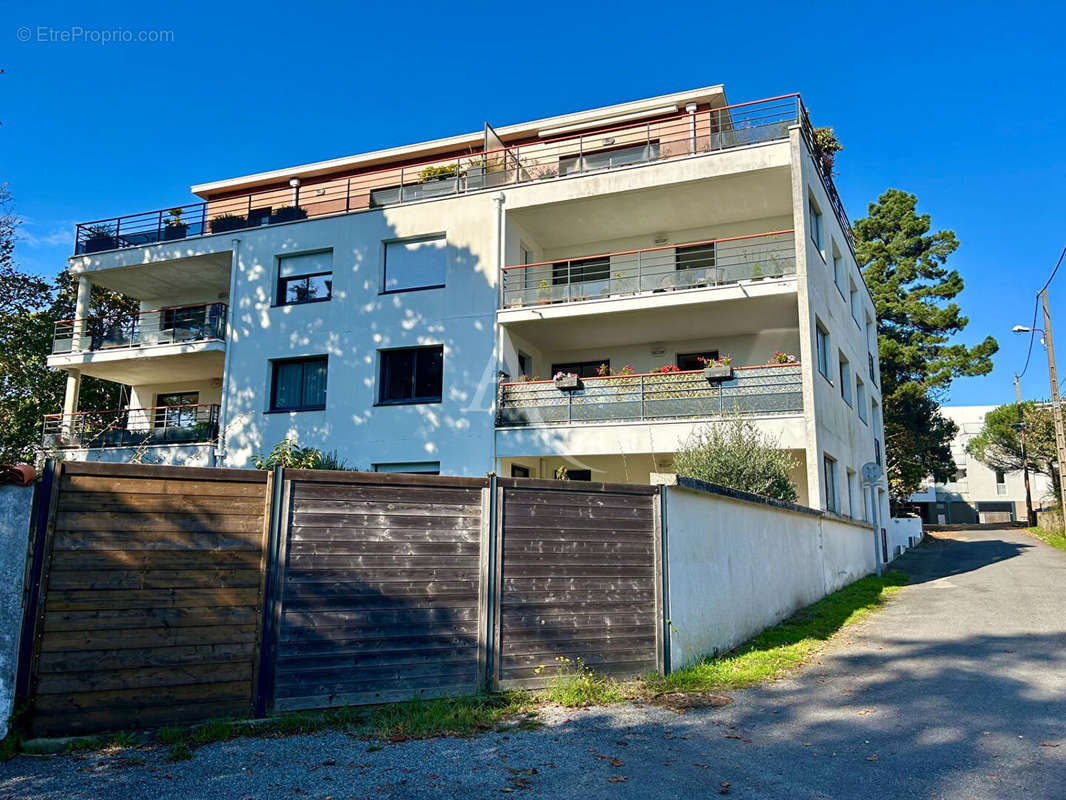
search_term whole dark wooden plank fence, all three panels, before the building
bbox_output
[26,463,662,735]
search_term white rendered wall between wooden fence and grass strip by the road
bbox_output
[663,478,875,670]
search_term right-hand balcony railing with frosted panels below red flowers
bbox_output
[497,363,803,428]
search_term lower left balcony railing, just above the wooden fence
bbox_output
[44,404,219,450]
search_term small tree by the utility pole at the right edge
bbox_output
[966,400,1059,495]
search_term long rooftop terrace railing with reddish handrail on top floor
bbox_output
[75,94,805,255]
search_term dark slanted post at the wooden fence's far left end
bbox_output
[15,459,62,702]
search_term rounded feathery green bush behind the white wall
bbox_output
[674,416,796,502]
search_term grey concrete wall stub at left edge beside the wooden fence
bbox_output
[0,485,33,738]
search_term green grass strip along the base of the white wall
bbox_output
[645,572,907,692]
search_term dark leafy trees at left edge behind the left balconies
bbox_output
[0,185,136,462]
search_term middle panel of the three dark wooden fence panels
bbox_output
[274,470,488,710]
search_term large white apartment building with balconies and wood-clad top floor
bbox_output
[46,86,887,517]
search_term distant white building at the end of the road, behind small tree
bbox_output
[910,405,1054,525]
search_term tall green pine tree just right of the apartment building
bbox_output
[854,189,999,503]
